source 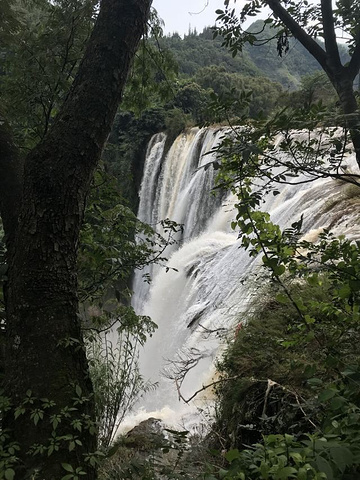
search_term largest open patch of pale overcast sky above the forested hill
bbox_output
[153,0,239,34]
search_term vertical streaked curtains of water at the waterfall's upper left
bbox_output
[133,128,223,312]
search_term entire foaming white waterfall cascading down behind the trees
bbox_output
[125,128,360,432]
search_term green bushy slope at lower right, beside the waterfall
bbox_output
[210,186,360,479]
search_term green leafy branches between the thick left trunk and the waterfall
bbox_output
[78,170,162,303]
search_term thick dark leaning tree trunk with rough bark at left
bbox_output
[0,0,151,480]
